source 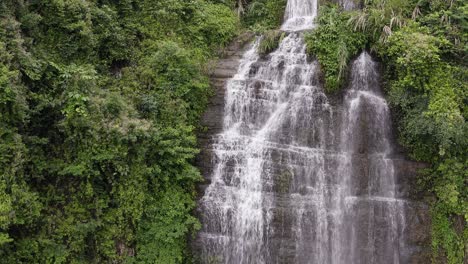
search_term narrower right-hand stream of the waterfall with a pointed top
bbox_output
[333,52,405,264]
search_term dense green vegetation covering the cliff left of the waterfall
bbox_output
[0,0,240,264]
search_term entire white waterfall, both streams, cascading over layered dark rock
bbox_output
[197,0,405,264]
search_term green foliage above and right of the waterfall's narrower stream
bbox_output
[306,0,468,264]
